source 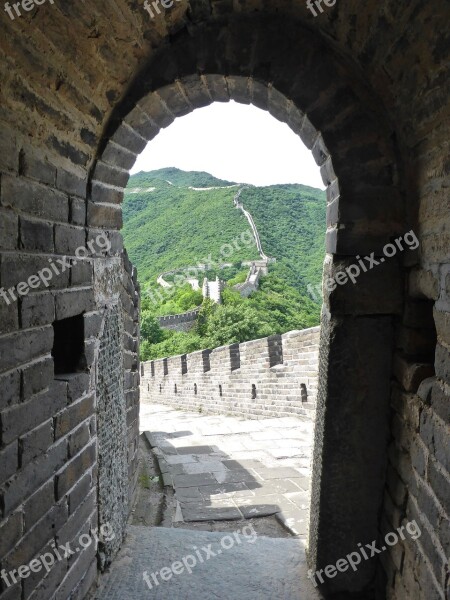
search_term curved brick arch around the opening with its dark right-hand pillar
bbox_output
[88,17,405,593]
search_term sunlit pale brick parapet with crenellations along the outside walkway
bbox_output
[141,327,320,419]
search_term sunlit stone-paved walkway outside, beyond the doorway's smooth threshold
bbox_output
[141,404,313,538]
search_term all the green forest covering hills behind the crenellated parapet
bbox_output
[123,168,326,360]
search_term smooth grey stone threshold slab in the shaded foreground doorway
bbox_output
[93,526,321,600]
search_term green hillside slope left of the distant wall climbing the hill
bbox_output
[123,169,258,285]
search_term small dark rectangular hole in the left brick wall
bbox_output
[52,314,86,375]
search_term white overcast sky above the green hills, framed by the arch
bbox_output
[131,102,325,189]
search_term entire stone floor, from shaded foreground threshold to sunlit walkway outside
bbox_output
[90,404,321,600]
